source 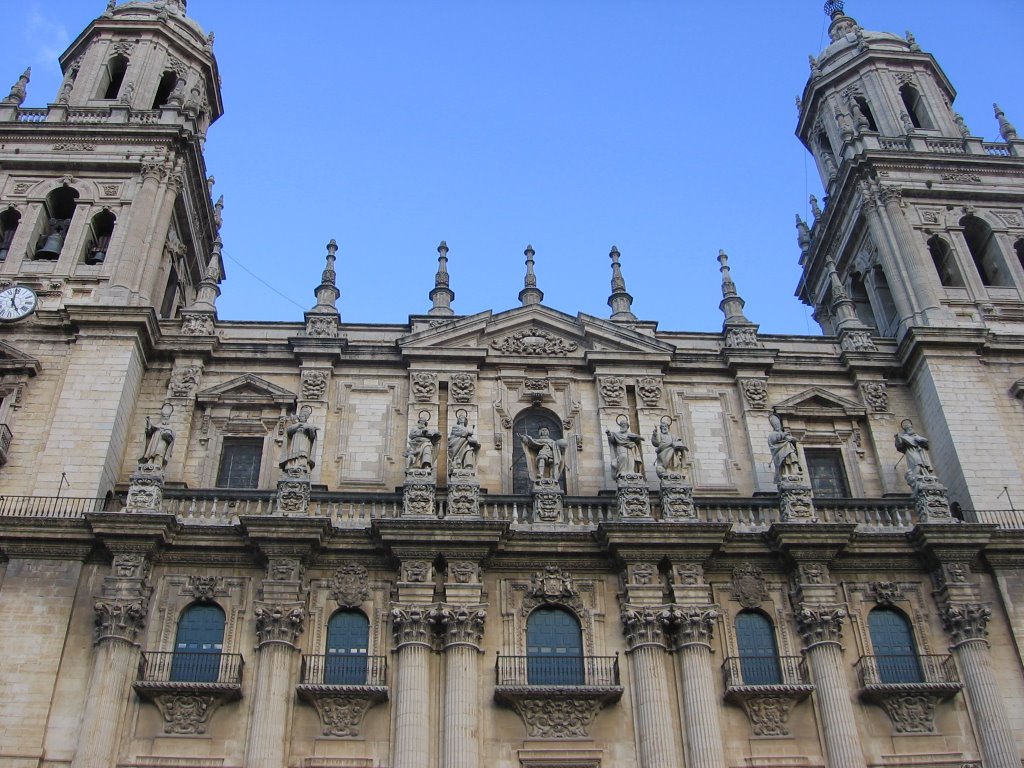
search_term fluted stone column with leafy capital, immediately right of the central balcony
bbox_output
[622,605,683,768]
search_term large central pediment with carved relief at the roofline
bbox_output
[398,304,675,360]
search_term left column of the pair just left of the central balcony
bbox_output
[391,605,431,768]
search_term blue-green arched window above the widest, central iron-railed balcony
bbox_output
[526,607,585,685]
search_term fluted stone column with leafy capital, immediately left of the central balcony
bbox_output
[434,605,487,768]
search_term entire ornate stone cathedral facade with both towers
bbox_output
[0,0,1024,768]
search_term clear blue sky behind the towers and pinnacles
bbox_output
[0,0,1024,333]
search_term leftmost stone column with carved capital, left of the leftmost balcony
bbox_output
[72,544,151,768]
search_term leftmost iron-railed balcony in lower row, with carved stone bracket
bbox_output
[132,652,244,734]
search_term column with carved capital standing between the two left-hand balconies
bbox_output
[246,557,306,768]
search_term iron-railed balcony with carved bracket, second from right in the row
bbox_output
[722,656,814,736]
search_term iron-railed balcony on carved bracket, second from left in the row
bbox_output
[297,653,388,738]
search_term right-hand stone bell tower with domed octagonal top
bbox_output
[797,0,1024,509]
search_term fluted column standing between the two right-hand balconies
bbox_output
[797,605,865,768]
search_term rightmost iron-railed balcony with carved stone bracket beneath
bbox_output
[856,654,964,733]
